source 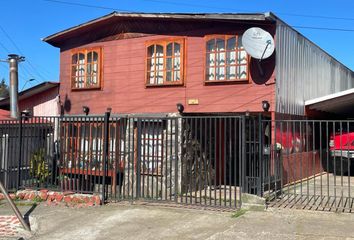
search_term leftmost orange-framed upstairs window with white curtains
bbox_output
[71,48,101,89]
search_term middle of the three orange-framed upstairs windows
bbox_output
[146,40,184,86]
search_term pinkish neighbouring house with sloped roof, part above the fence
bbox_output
[0,82,60,116]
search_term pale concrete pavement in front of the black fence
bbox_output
[0,204,354,240]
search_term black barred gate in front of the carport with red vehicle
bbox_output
[261,120,354,212]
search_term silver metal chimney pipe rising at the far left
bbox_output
[8,54,24,119]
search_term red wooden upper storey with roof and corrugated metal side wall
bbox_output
[44,12,354,119]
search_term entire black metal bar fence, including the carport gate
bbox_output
[0,113,354,211]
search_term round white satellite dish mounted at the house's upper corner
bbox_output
[242,27,274,61]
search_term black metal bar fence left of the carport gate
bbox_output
[0,113,246,208]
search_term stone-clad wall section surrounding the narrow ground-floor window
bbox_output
[120,114,182,200]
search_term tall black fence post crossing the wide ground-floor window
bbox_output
[102,112,111,203]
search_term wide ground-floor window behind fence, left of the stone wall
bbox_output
[61,121,124,171]
